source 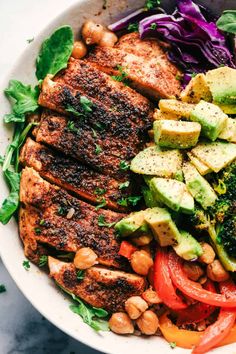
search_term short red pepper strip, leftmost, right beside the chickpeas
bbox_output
[153,248,187,310]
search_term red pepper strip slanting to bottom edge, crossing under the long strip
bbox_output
[192,281,236,354]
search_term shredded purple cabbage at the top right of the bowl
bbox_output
[139,0,235,73]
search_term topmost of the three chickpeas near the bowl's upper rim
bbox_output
[82,20,105,45]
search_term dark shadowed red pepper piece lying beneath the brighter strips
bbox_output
[176,280,216,326]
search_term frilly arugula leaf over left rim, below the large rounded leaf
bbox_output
[4,80,39,119]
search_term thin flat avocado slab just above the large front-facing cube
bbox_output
[159,99,195,118]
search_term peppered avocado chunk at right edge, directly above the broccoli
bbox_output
[191,141,236,172]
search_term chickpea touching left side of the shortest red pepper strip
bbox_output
[130,250,153,275]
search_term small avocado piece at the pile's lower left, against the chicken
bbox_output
[115,210,146,237]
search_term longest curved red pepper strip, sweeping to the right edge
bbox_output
[168,252,236,308]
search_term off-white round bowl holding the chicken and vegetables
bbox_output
[0,0,236,354]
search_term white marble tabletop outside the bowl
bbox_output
[0,0,103,354]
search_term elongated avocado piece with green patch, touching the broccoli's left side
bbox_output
[183,162,217,209]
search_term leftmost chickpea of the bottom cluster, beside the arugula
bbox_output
[109,312,134,334]
